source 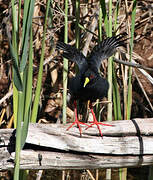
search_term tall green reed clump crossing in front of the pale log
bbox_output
[12,0,35,180]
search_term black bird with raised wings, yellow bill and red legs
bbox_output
[56,33,126,136]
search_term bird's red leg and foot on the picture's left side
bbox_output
[66,101,89,136]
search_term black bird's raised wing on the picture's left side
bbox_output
[56,41,88,72]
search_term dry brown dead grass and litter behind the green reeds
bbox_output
[0,0,153,179]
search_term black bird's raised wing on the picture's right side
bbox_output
[88,33,127,69]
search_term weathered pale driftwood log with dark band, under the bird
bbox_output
[0,118,153,170]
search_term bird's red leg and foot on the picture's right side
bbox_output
[86,102,112,136]
